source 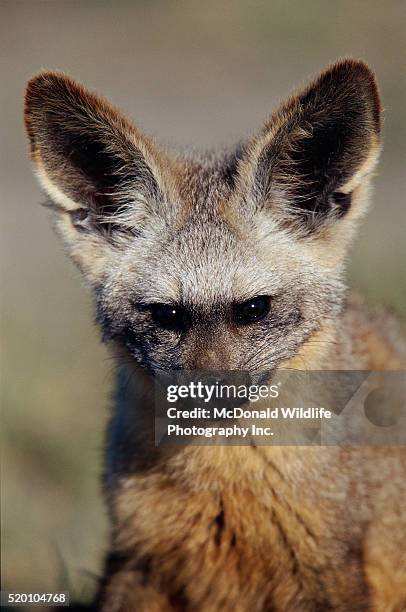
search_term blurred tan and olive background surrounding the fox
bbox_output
[0,0,406,596]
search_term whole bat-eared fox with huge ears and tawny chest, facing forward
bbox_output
[25,59,406,612]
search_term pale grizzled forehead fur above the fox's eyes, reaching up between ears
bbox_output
[99,151,326,308]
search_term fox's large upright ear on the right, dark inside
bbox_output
[239,60,381,235]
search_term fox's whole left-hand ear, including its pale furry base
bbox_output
[25,72,173,277]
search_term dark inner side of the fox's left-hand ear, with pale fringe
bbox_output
[25,73,171,232]
